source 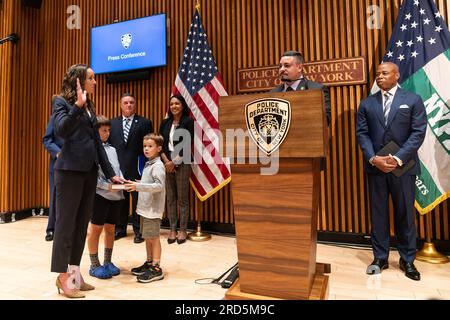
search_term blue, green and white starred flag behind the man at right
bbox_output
[373,0,450,214]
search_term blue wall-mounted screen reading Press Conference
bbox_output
[91,14,167,74]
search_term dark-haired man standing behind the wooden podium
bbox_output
[271,51,331,125]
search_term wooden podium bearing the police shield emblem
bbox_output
[219,90,330,300]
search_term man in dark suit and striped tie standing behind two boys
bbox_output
[109,93,153,243]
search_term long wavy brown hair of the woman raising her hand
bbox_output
[60,64,94,110]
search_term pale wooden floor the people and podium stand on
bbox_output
[0,217,450,300]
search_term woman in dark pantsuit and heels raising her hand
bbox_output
[51,64,121,298]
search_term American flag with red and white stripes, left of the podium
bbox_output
[172,9,231,201]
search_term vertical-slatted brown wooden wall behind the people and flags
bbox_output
[0,0,450,240]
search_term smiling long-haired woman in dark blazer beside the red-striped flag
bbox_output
[159,94,194,244]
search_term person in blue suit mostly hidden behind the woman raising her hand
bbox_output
[42,115,64,241]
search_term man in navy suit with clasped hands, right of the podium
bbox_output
[356,62,427,280]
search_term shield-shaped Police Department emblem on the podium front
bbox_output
[245,98,292,156]
